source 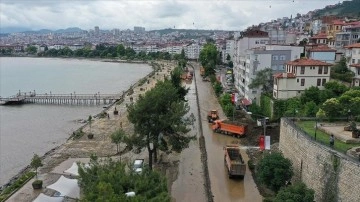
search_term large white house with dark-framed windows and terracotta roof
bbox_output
[273,58,332,99]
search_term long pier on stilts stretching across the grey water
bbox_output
[0,91,121,105]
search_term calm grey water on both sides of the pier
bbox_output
[0,57,151,186]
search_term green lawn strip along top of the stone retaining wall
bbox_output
[297,121,360,153]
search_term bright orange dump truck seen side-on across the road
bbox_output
[211,120,247,138]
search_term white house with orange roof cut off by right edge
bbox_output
[345,43,360,86]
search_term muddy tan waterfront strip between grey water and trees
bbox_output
[7,61,178,201]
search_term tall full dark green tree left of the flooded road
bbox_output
[127,80,194,169]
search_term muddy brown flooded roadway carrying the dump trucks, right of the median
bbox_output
[194,62,262,202]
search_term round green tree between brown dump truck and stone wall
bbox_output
[256,152,293,192]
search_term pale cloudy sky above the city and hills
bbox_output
[0,0,339,30]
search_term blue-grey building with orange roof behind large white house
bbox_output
[306,45,336,64]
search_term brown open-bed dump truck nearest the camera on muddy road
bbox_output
[224,145,246,178]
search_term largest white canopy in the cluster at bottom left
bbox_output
[46,175,80,199]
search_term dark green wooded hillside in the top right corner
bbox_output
[314,0,360,18]
